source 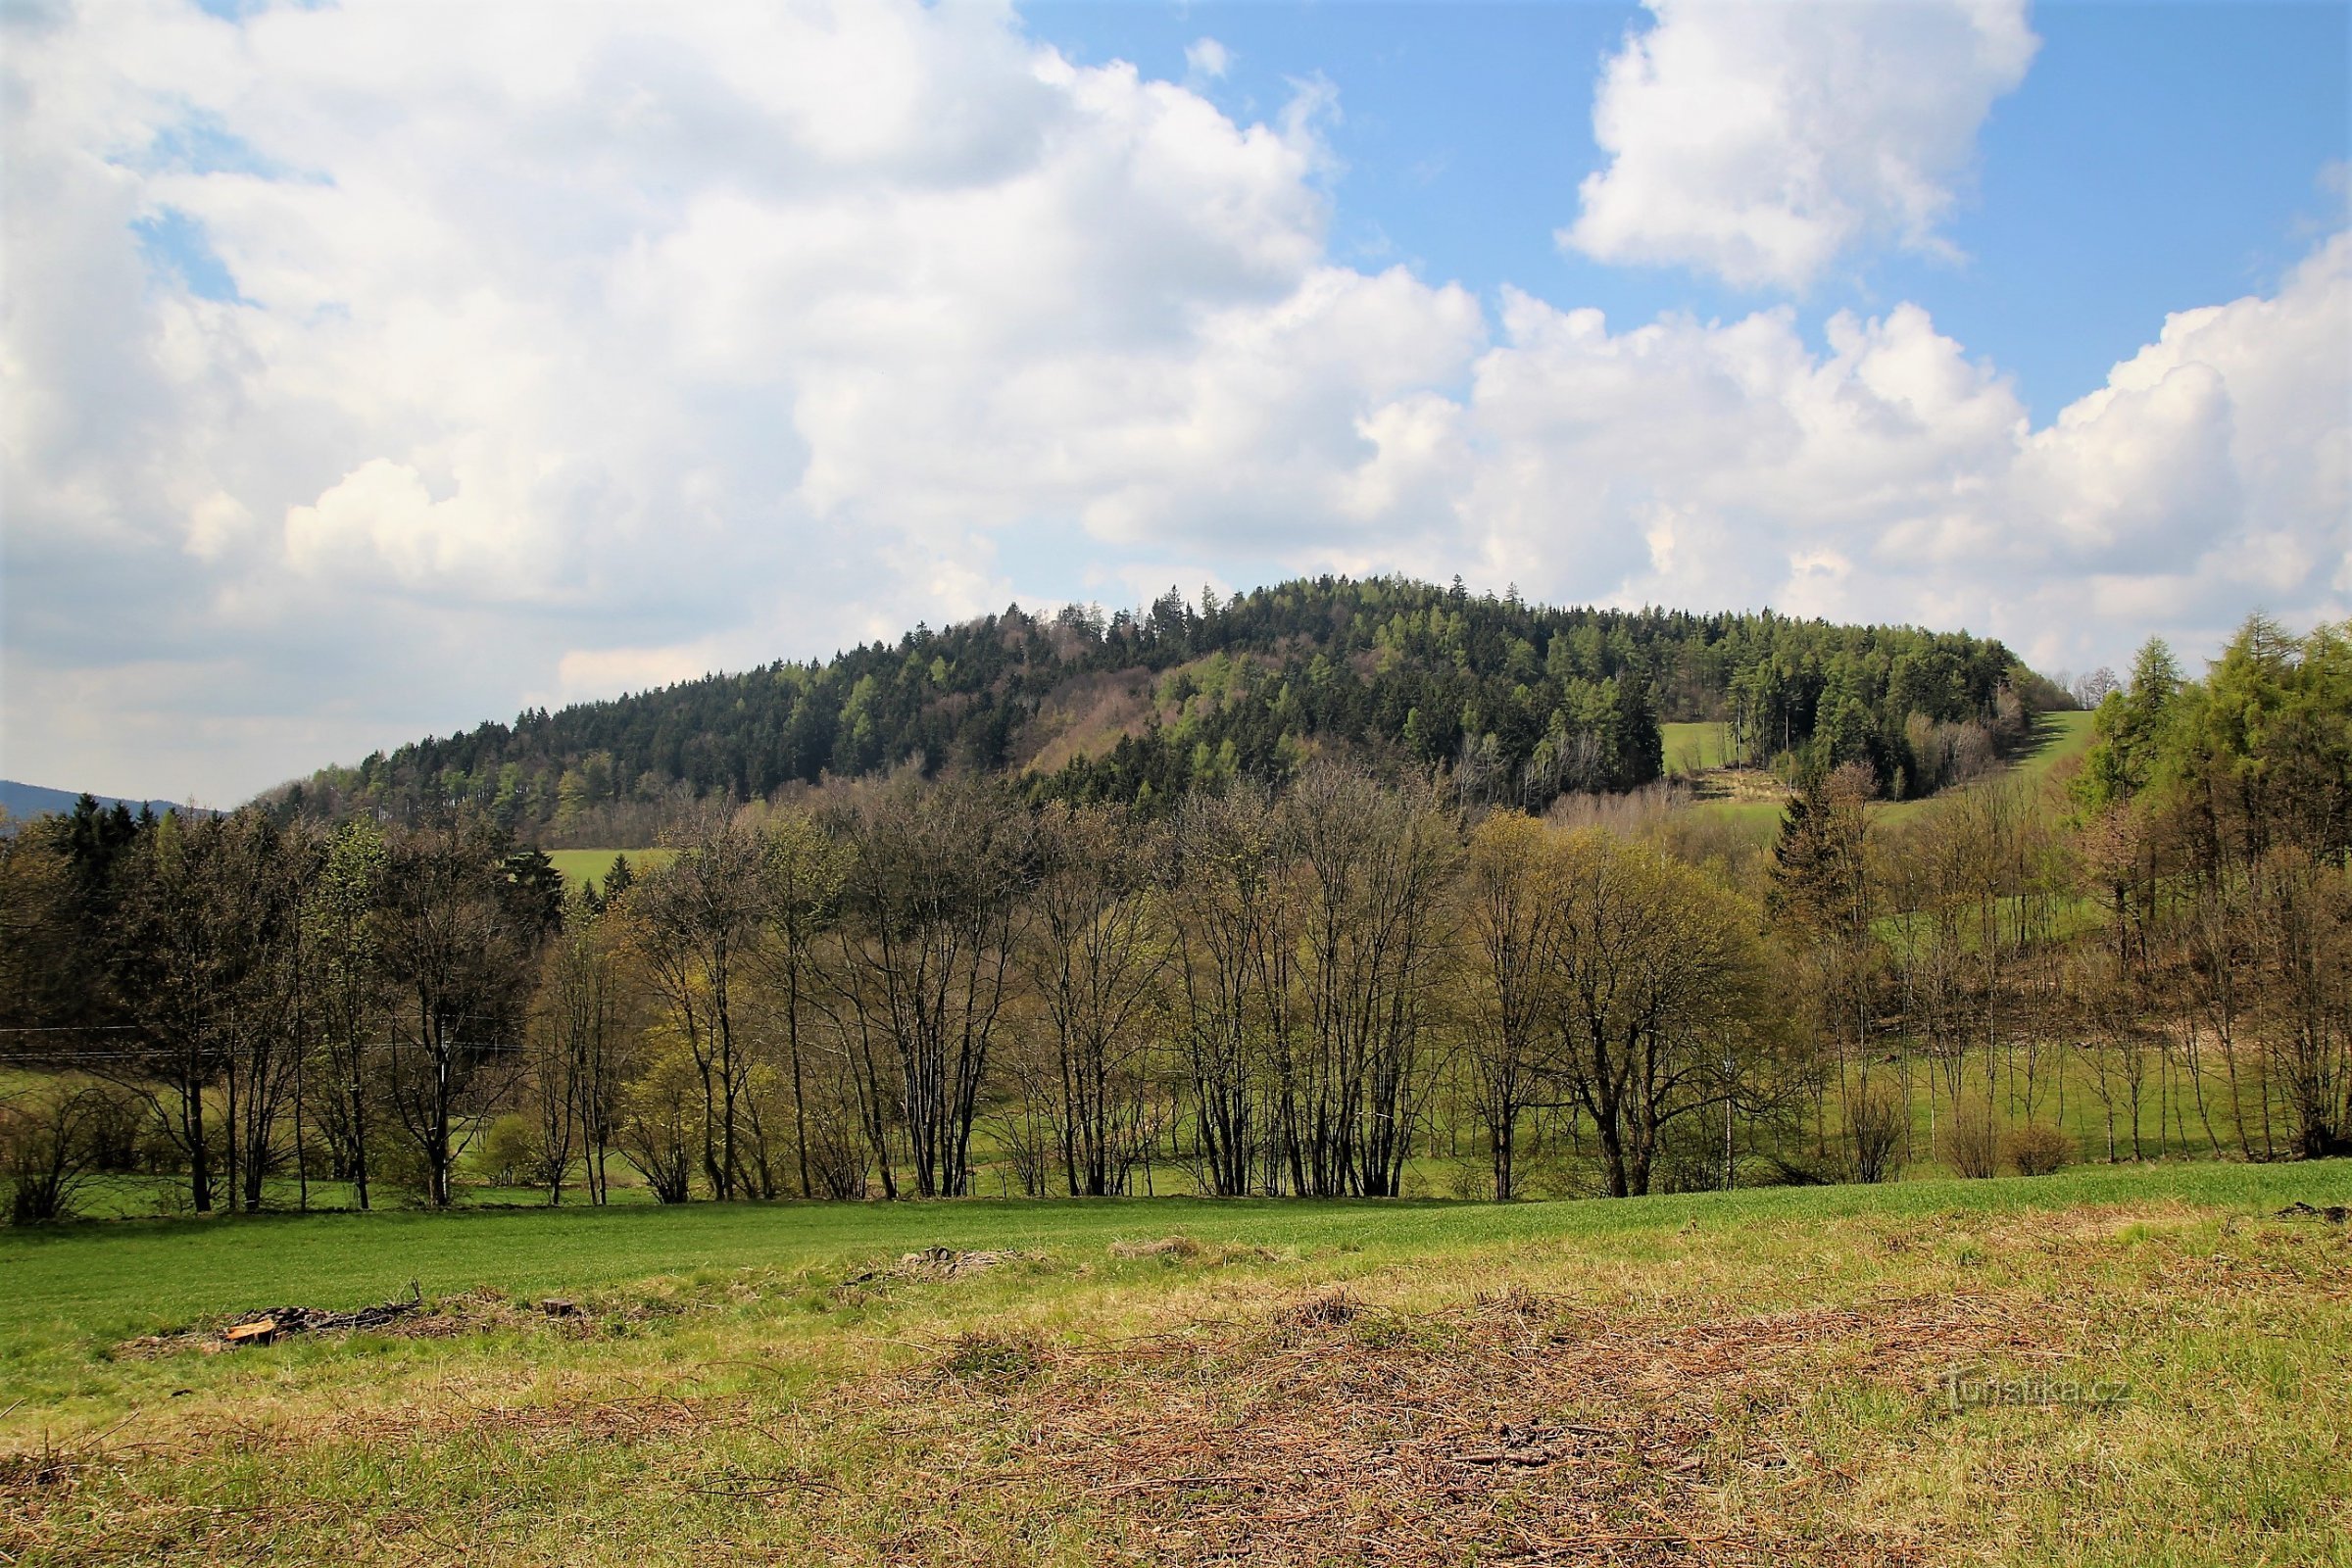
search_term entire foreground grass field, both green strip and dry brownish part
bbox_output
[0,1161,2352,1563]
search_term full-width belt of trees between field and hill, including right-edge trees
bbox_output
[0,623,2352,1218]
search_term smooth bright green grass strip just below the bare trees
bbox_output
[0,1161,2352,1356]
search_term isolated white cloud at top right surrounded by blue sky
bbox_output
[1559,0,2036,289]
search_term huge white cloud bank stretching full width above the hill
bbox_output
[0,0,2352,802]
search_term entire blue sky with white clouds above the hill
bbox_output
[0,0,2352,804]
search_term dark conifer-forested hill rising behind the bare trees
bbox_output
[269,578,2065,842]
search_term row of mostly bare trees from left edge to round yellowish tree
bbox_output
[0,764,1786,1218]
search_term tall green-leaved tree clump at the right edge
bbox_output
[2077,615,2352,1156]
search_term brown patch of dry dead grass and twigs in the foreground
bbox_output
[837,1291,2033,1566]
